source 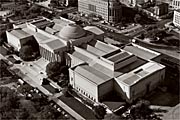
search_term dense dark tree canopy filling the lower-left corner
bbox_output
[0,87,65,120]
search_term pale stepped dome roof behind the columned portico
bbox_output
[59,24,86,39]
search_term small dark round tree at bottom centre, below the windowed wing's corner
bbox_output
[93,105,106,119]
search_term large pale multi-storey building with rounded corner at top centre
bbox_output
[78,0,122,23]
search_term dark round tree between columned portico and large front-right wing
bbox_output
[46,62,62,78]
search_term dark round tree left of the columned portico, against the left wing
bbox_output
[19,45,34,61]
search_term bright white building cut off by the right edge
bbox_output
[173,9,180,29]
